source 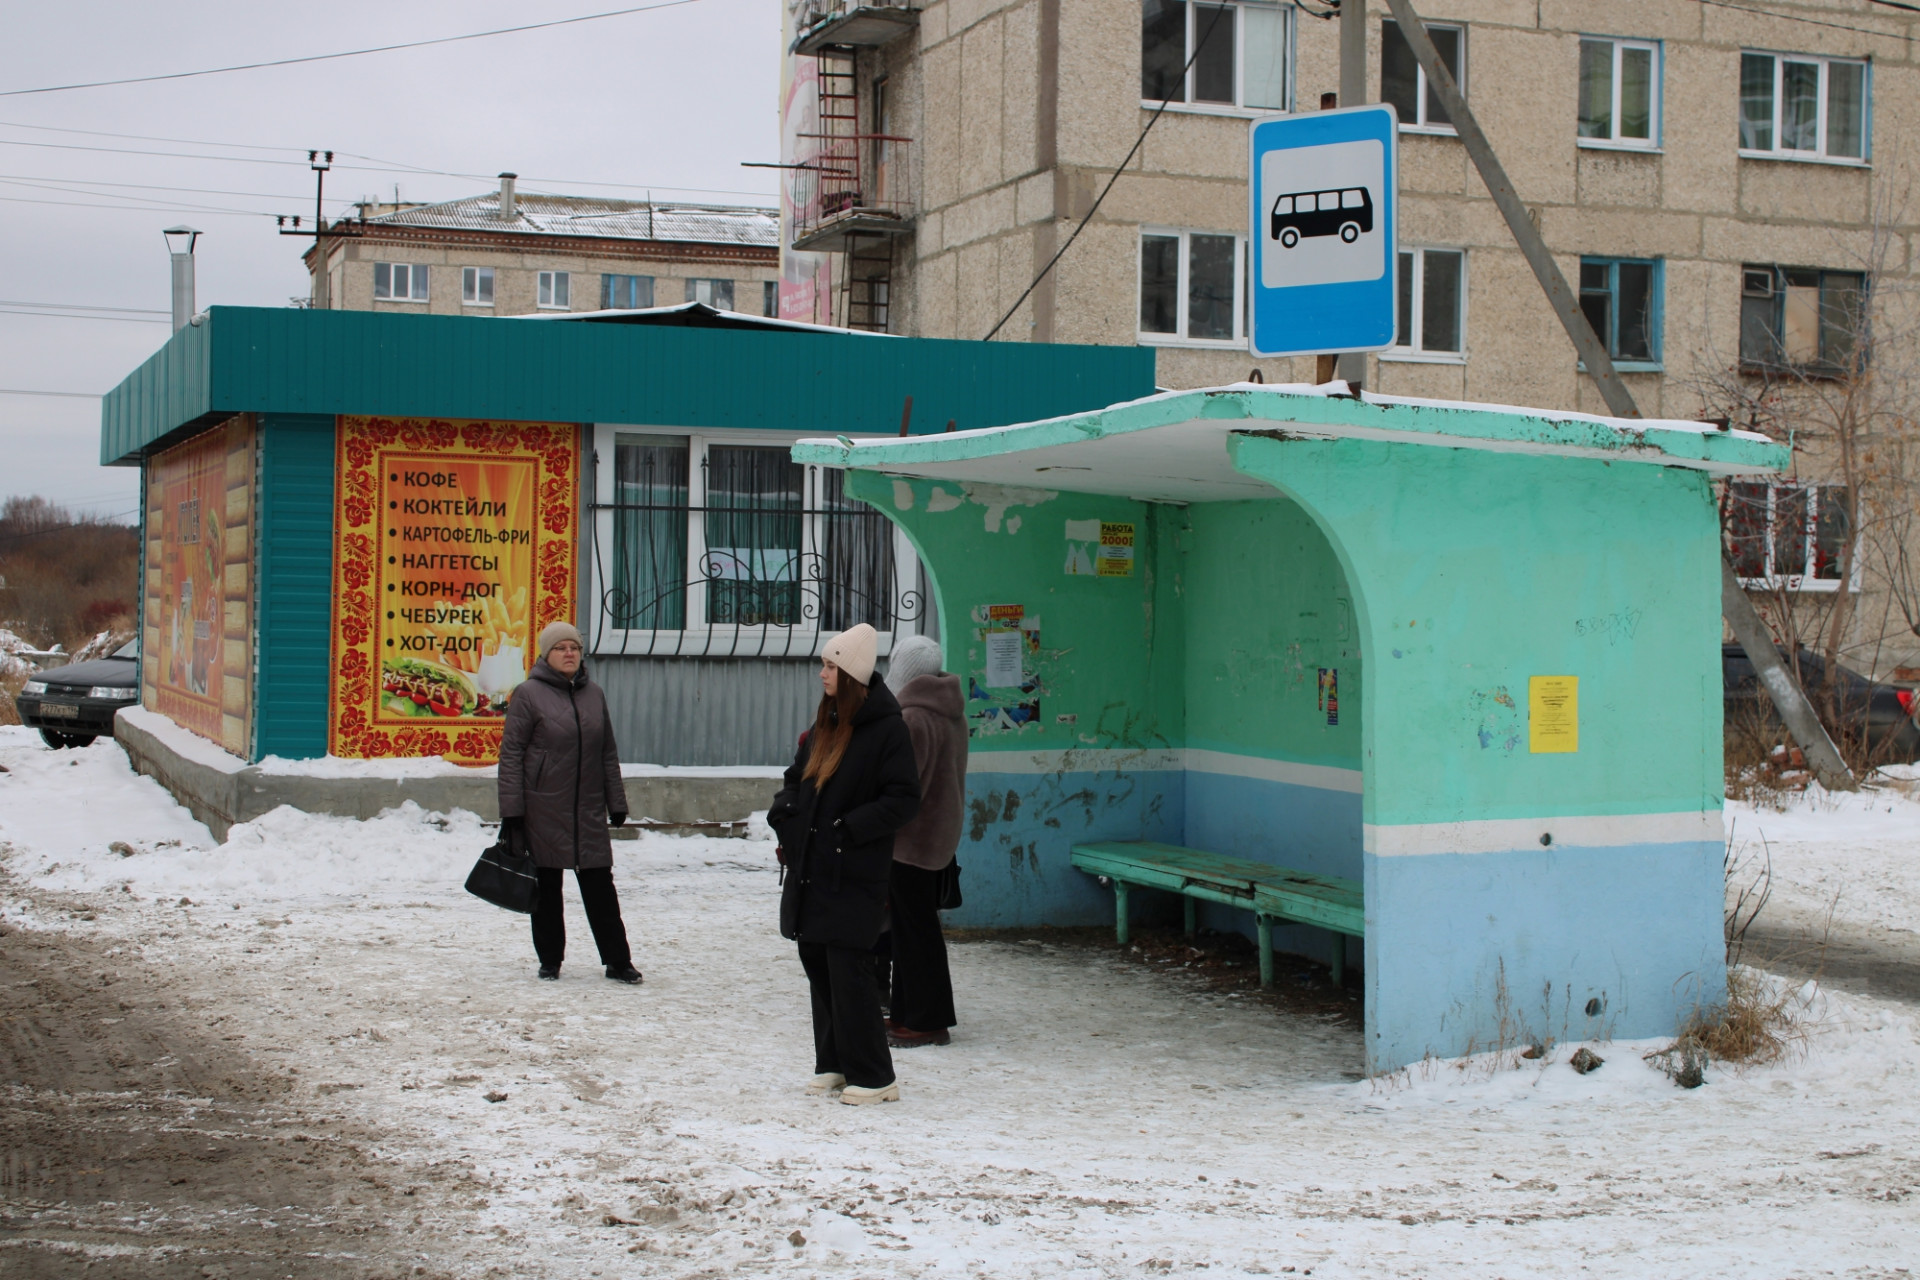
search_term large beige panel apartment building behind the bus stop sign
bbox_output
[787,0,1920,670]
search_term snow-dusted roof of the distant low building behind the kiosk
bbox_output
[349,190,780,249]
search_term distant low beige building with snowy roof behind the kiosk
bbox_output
[305,173,780,317]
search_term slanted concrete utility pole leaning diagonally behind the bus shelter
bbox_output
[1382,0,1859,791]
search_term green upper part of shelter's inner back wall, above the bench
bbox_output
[1181,499,1361,770]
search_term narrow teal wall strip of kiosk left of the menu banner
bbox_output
[253,415,334,760]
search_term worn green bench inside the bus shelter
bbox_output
[1073,841,1365,986]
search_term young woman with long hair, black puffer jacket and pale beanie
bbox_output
[768,622,920,1103]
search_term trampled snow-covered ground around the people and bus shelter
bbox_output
[0,729,1920,1278]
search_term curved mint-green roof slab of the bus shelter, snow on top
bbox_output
[793,382,1789,503]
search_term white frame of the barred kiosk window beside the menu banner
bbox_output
[588,422,931,658]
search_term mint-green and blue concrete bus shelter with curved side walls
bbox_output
[793,384,1789,1071]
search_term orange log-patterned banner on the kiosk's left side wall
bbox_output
[140,415,253,758]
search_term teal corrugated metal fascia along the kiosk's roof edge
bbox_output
[100,307,1154,464]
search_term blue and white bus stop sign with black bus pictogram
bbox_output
[1248,104,1400,355]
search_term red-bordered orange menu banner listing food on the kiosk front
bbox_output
[328,416,580,766]
